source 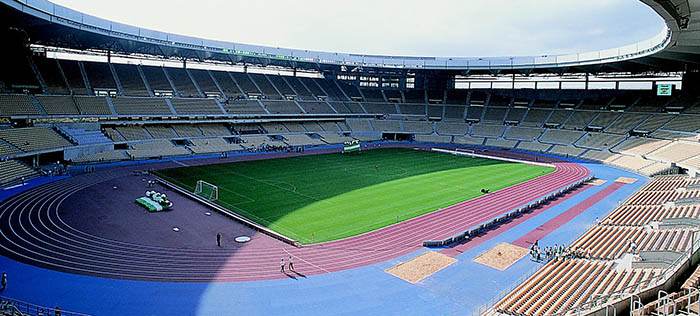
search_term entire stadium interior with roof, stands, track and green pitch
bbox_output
[0,0,700,316]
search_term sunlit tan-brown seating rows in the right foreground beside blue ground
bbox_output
[494,176,698,315]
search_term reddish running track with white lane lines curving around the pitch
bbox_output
[0,162,590,282]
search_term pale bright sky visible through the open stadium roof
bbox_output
[51,0,663,57]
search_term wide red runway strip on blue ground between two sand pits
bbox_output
[513,182,625,248]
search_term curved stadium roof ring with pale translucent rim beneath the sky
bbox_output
[0,0,700,73]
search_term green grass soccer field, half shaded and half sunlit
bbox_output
[157,149,554,244]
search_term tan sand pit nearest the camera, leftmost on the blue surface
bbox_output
[386,251,457,284]
